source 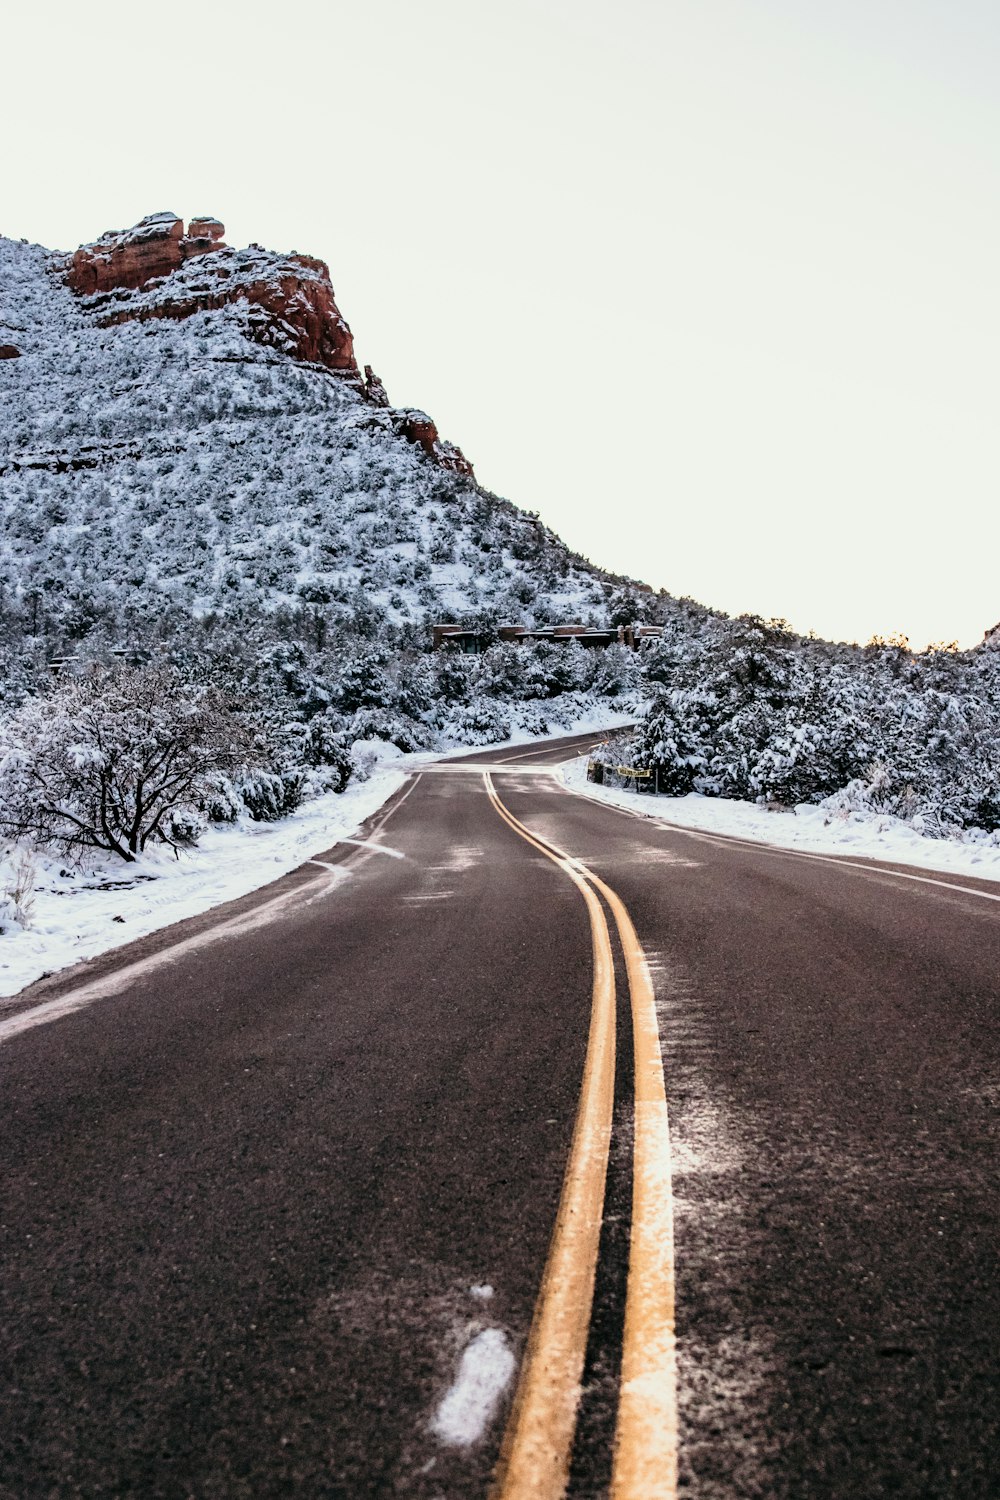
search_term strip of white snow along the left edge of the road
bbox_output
[0,708,634,998]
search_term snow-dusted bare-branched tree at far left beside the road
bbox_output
[0,666,268,861]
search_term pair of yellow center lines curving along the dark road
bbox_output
[484,773,678,1500]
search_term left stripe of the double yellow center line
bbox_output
[484,773,615,1500]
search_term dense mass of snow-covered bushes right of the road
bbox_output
[627,617,1000,836]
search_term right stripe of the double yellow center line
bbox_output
[485,786,678,1500]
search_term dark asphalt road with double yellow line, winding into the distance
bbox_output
[0,735,1000,1500]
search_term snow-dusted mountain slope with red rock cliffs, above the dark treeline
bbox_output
[0,215,656,669]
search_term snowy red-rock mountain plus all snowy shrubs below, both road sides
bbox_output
[0,213,1000,972]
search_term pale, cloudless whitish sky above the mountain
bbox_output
[0,0,1000,645]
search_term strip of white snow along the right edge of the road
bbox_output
[561,756,1000,881]
